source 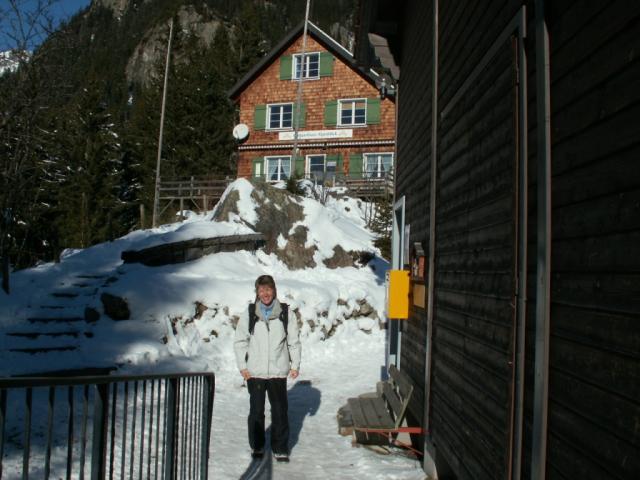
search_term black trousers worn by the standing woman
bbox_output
[247,378,289,453]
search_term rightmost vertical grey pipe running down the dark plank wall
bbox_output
[531,0,551,480]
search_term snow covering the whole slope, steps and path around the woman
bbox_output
[0,180,424,479]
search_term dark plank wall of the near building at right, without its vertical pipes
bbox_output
[397,0,640,480]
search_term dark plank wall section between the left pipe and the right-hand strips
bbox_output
[432,27,516,479]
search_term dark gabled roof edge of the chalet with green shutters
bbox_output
[227,21,390,99]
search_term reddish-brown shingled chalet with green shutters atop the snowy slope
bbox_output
[229,23,395,192]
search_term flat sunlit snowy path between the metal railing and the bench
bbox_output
[209,321,425,480]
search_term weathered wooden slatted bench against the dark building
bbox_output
[347,365,424,454]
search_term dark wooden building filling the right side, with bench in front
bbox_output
[356,0,640,480]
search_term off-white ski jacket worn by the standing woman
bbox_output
[233,299,302,378]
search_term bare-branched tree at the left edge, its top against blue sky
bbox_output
[0,0,58,293]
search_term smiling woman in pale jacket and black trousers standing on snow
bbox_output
[234,275,301,462]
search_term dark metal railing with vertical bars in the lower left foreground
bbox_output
[0,373,215,480]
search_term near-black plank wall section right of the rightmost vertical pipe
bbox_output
[528,0,640,480]
